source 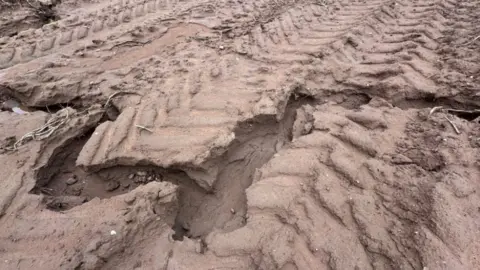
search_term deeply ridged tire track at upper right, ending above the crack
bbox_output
[284,1,458,100]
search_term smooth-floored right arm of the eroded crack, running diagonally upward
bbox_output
[173,95,316,241]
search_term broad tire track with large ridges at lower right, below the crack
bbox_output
[204,100,479,269]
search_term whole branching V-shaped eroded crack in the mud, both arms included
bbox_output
[31,94,316,240]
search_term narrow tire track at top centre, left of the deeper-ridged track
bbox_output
[235,1,387,63]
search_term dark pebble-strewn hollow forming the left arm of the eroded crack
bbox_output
[31,129,199,211]
